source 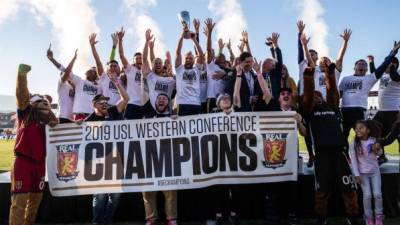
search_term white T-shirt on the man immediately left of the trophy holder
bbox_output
[146,72,175,109]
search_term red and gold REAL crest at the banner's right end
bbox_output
[262,133,288,169]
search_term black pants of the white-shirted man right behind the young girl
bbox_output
[341,107,365,149]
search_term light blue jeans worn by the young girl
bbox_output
[360,169,383,218]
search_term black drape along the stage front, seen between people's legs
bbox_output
[0,173,400,224]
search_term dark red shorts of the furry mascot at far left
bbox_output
[11,156,46,194]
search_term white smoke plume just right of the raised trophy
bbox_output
[208,0,247,53]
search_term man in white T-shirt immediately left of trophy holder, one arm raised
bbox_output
[142,29,175,118]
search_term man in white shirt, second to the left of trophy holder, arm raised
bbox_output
[117,28,149,119]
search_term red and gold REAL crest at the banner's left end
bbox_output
[56,144,79,182]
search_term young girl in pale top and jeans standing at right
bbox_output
[349,120,383,225]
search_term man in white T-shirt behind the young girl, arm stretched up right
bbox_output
[339,42,400,149]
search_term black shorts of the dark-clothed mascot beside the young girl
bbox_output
[314,149,357,193]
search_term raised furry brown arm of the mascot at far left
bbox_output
[15,64,31,111]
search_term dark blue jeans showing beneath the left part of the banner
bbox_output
[92,193,121,224]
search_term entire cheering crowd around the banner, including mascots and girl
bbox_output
[10,16,400,225]
